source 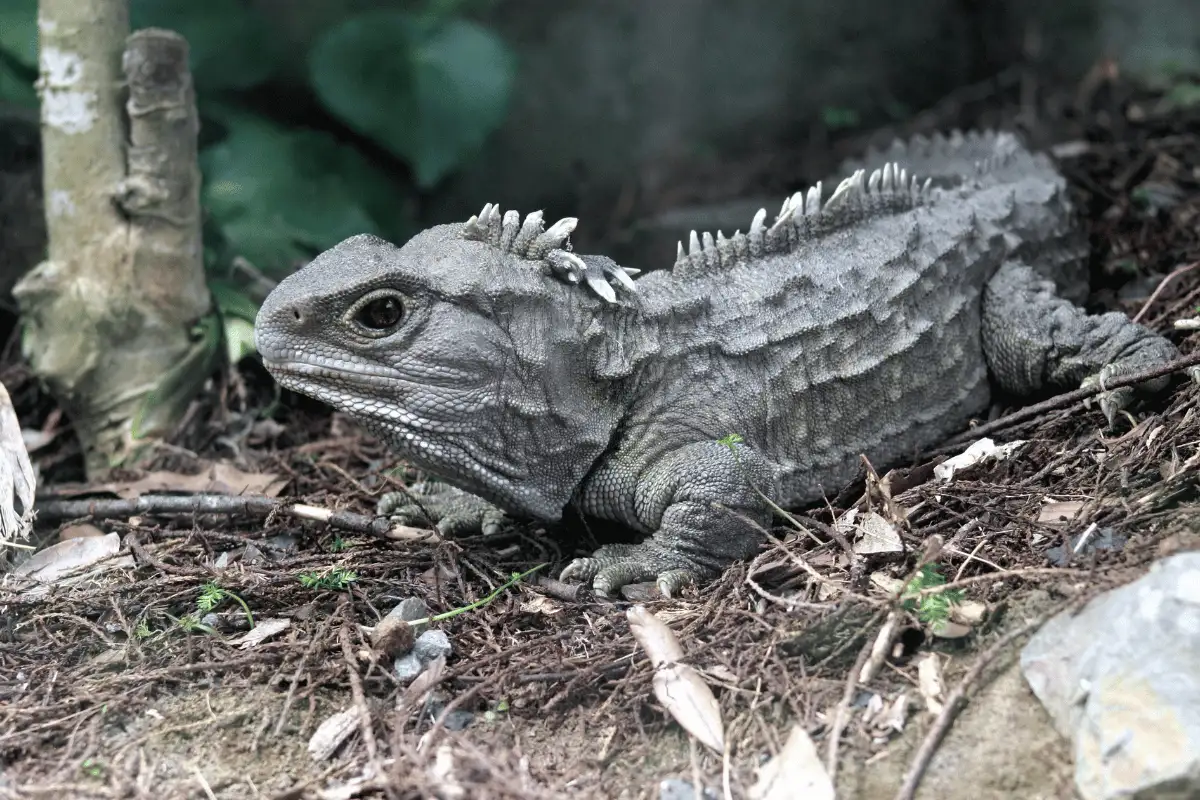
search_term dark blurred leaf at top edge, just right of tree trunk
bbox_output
[130,0,281,91]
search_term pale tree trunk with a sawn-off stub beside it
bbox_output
[13,0,222,476]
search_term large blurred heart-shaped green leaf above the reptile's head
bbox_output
[308,11,516,188]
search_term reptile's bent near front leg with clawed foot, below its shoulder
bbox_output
[560,441,773,597]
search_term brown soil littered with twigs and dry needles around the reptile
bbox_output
[0,65,1200,800]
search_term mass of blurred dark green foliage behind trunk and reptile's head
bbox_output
[0,0,516,355]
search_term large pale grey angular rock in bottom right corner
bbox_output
[1021,553,1200,800]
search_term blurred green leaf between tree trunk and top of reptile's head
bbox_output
[200,113,410,275]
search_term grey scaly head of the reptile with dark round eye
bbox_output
[254,225,617,521]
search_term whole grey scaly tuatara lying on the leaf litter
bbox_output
[256,133,1177,595]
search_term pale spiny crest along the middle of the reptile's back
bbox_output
[674,163,931,273]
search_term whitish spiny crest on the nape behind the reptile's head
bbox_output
[462,203,641,303]
